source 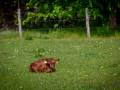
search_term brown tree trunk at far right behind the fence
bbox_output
[110,10,117,30]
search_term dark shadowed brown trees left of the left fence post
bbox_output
[0,0,17,29]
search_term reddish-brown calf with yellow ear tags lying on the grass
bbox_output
[29,58,60,73]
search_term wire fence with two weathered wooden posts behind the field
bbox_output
[0,8,120,37]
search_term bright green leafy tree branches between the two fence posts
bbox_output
[22,0,88,28]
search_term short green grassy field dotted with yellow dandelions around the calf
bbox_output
[0,32,120,90]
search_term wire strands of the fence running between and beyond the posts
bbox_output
[0,19,120,31]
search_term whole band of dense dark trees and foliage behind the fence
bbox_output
[0,0,120,29]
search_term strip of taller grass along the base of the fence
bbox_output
[0,28,120,40]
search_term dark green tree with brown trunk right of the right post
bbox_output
[89,0,120,28]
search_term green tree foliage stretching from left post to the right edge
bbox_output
[23,0,120,28]
